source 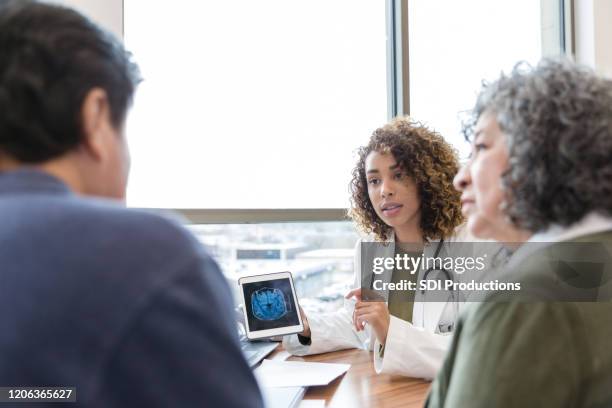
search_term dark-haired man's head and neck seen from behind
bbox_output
[0,0,140,199]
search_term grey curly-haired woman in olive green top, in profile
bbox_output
[427,60,612,407]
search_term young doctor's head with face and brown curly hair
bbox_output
[350,118,463,243]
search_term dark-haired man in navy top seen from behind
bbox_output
[0,1,263,407]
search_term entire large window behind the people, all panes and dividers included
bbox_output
[124,0,563,310]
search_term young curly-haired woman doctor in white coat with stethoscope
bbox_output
[283,118,463,379]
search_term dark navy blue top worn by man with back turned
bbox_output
[0,170,263,407]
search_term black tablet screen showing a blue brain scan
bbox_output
[242,278,300,331]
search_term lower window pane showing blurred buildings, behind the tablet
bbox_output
[189,221,357,311]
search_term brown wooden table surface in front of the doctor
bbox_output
[270,349,431,408]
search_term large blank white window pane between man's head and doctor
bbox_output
[124,0,388,209]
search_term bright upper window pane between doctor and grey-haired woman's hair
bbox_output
[408,0,561,157]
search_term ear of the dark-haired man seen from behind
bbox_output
[81,88,112,161]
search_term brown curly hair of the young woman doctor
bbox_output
[349,117,463,241]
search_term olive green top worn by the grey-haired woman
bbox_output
[425,232,612,408]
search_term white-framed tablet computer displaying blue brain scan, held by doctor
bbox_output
[238,272,304,340]
